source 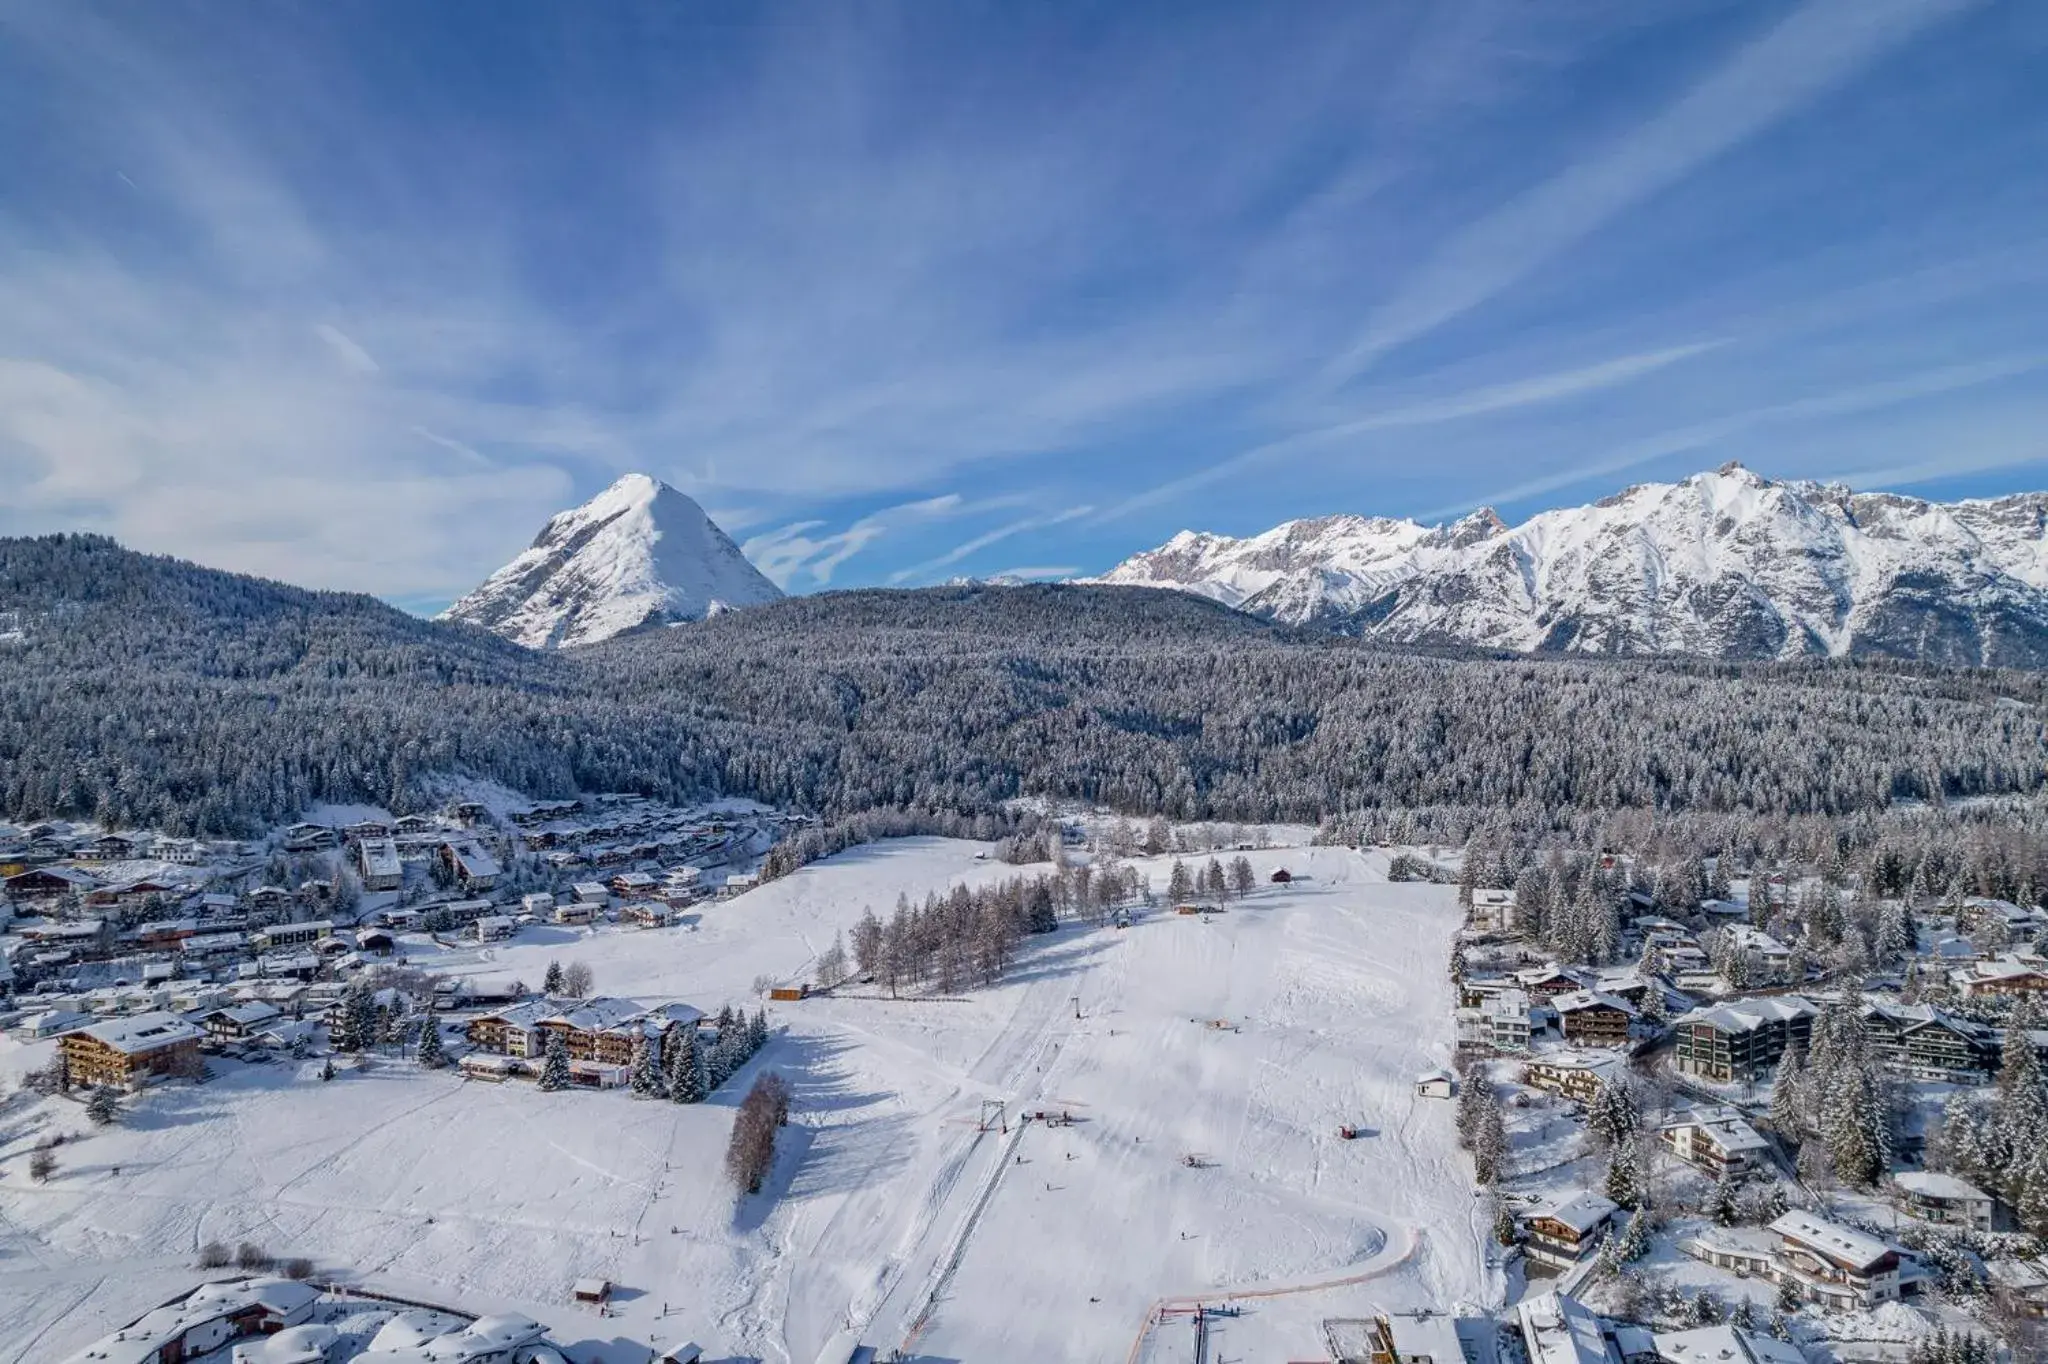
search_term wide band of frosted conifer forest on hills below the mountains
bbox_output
[0,537,2044,832]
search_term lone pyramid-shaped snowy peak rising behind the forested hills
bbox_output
[442,473,782,649]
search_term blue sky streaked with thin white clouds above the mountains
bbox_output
[0,0,2048,608]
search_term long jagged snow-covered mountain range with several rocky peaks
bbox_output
[1098,465,2048,668]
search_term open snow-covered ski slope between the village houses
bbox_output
[0,840,1505,1364]
